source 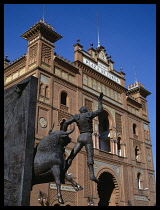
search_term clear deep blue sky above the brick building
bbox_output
[4,4,156,177]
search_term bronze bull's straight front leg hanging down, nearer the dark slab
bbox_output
[51,165,64,204]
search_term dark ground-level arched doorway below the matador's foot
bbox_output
[97,172,116,206]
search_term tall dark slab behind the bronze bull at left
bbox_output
[4,76,38,206]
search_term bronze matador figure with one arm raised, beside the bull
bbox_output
[63,93,103,183]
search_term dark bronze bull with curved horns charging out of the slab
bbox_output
[32,125,83,204]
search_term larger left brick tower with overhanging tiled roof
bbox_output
[21,20,62,71]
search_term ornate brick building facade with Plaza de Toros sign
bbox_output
[4,20,156,206]
